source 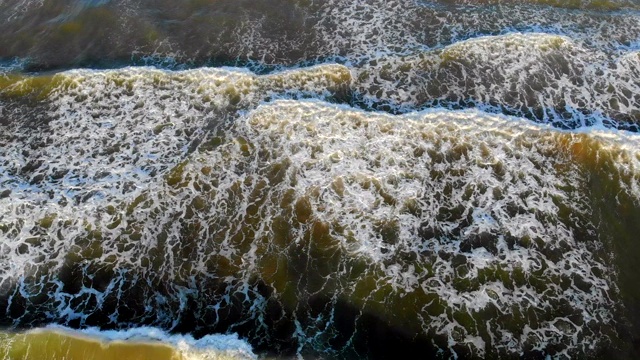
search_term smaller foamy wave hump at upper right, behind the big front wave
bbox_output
[355,33,640,128]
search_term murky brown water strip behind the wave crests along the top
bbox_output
[0,0,640,70]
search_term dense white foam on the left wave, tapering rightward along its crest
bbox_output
[0,65,350,316]
